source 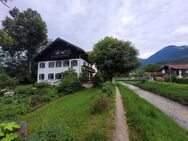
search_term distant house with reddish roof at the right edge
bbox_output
[161,64,188,78]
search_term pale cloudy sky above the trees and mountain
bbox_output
[0,0,188,58]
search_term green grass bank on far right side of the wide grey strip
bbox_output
[127,81,188,105]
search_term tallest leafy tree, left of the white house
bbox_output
[0,8,47,82]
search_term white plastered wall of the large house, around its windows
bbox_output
[37,58,90,84]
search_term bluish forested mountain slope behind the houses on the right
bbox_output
[141,45,188,65]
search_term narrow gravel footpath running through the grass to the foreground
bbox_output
[114,87,129,141]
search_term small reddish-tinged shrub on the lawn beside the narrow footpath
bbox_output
[92,96,109,115]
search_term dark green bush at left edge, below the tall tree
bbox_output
[0,73,17,89]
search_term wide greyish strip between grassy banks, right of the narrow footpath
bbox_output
[122,82,188,129]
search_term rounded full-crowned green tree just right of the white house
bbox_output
[91,37,138,80]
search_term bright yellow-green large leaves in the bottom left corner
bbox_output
[0,122,20,141]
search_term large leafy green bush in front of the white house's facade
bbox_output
[59,69,81,94]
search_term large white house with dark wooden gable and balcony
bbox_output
[34,38,95,85]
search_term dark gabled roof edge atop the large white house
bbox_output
[33,38,85,61]
